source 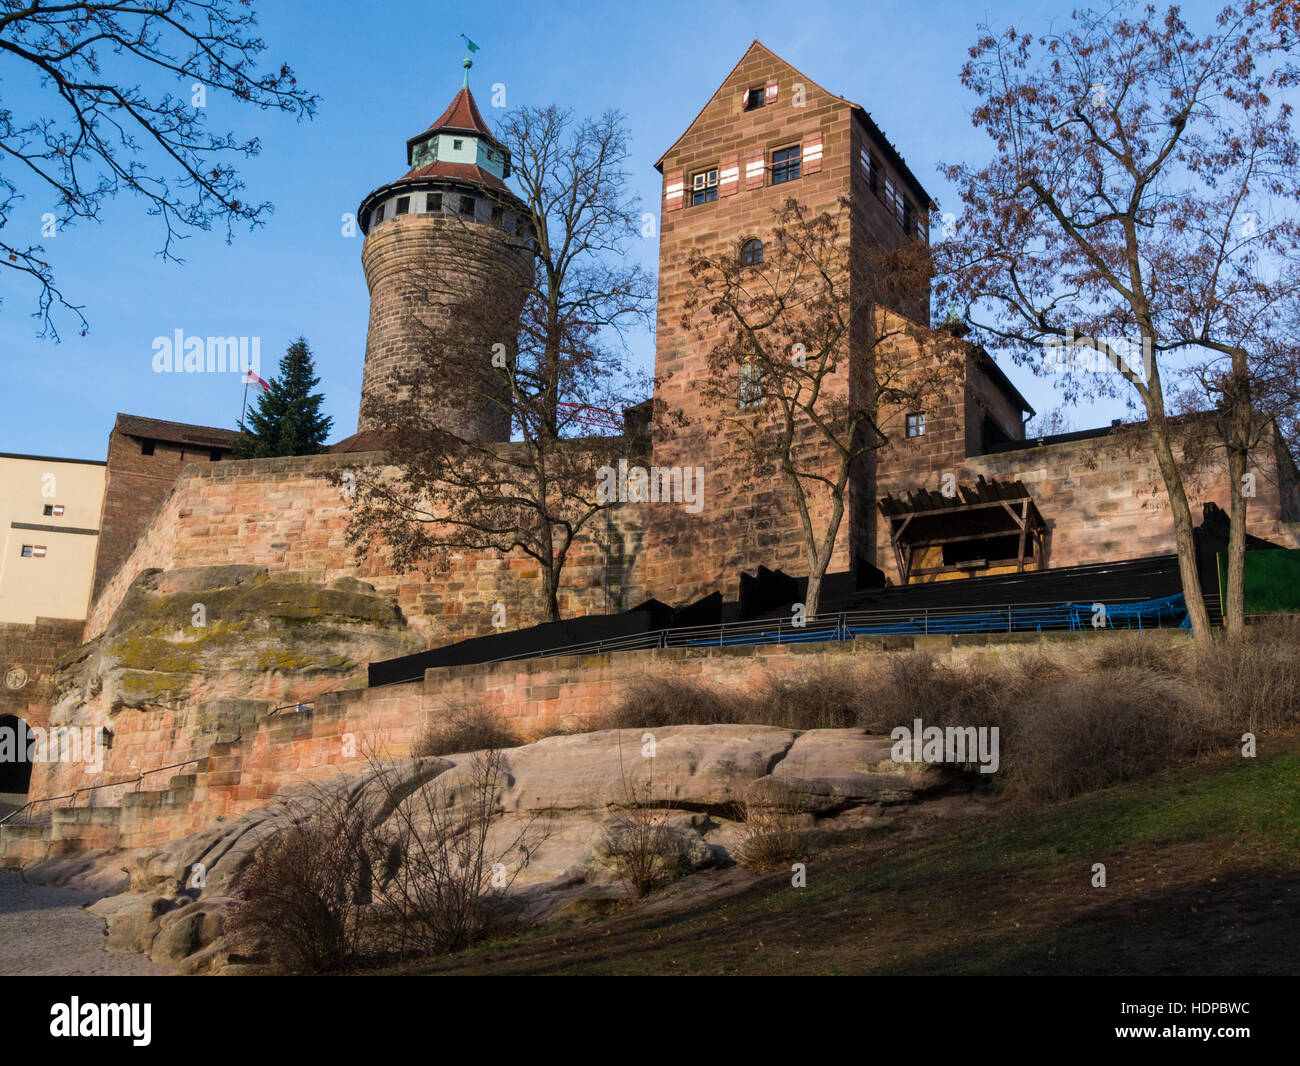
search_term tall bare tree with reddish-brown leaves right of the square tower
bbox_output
[939,4,1300,637]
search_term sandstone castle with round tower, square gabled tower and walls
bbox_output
[0,42,1300,816]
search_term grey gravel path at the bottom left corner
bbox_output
[0,870,172,976]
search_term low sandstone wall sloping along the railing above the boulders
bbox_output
[0,631,1187,866]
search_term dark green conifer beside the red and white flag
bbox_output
[235,337,334,459]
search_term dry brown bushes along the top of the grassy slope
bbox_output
[595,616,1300,806]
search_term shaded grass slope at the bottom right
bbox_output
[389,737,1300,975]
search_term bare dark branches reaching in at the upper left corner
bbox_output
[0,0,317,339]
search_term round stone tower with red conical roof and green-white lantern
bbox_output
[356,77,533,442]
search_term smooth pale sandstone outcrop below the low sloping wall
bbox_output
[15,725,983,974]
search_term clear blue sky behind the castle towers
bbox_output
[0,0,1237,459]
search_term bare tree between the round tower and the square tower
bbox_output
[348,107,654,620]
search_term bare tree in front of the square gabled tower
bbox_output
[683,198,956,615]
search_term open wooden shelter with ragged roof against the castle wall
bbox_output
[880,476,1052,585]
